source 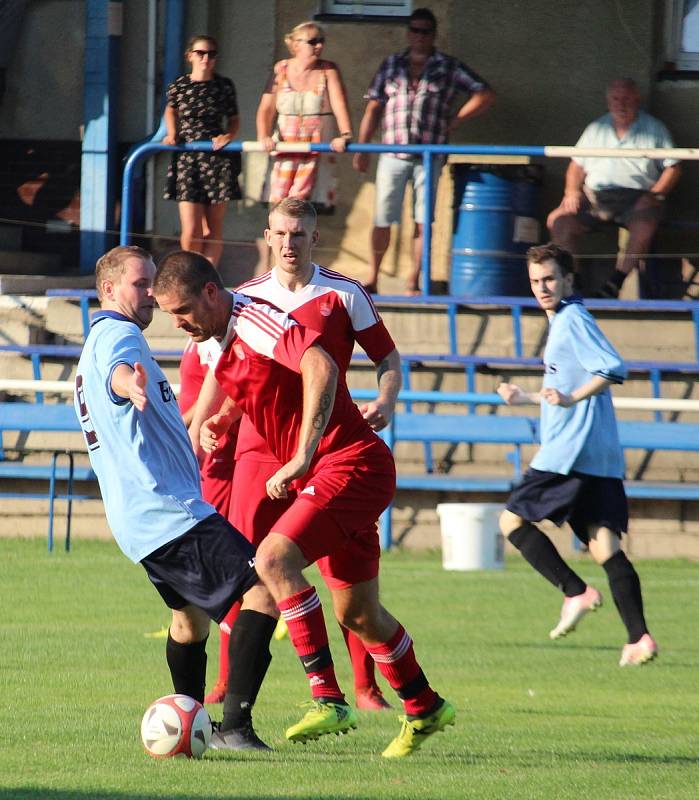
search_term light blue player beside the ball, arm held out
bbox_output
[75,247,277,750]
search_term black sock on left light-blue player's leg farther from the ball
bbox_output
[221,610,277,731]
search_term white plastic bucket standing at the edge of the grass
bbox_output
[437,503,505,570]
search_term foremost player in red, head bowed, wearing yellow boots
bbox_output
[154,227,455,758]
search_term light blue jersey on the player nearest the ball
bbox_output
[75,311,215,562]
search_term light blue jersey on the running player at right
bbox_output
[531,297,626,478]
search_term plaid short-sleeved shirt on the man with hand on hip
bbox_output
[365,50,490,158]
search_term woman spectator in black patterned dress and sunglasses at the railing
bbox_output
[163,36,241,266]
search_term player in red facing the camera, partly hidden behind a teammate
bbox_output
[204,198,401,710]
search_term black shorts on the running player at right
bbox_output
[506,468,629,544]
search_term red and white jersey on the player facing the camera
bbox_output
[235,264,395,461]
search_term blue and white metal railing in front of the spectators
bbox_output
[120,140,699,297]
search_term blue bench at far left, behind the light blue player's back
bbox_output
[0,403,98,551]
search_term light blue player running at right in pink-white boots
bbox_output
[498,244,658,667]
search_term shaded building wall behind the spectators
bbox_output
[0,0,699,286]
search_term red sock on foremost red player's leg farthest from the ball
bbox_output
[366,623,437,716]
